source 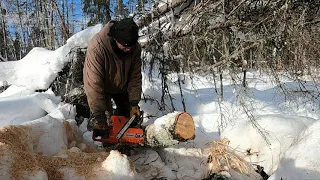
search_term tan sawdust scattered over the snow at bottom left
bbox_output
[0,126,109,180]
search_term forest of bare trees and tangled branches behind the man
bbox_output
[0,0,320,124]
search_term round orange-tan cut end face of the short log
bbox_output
[175,112,195,140]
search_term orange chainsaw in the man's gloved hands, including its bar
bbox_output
[92,111,144,146]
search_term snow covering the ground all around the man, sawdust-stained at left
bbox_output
[0,25,320,179]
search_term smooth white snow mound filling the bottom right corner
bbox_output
[270,121,320,180]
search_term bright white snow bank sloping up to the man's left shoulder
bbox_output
[0,24,102,90]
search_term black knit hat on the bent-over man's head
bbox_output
[110,18,139,47]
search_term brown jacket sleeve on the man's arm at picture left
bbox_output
[83,47,107,114]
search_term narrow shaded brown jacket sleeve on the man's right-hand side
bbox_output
[128,45,142,103]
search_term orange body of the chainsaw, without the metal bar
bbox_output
[92,115,144,145]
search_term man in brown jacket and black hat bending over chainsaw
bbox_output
[83,18,142,136]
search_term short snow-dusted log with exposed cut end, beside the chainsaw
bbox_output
[145,111,195,147]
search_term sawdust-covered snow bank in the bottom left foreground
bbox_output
[0,106,136,180]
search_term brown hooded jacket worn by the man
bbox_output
[83,21,142,113]
